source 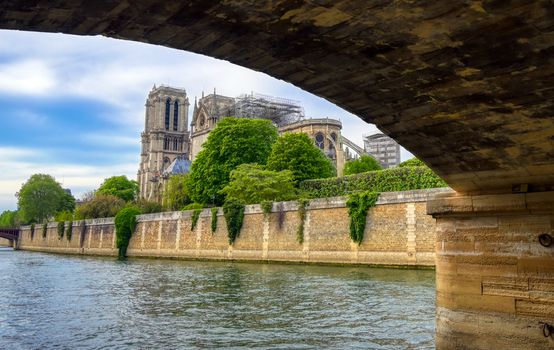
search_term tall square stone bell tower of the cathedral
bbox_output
[138,85,190,203]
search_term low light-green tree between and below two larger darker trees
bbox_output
[221,164,296,204]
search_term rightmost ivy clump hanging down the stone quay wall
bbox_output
[346,191,379,245]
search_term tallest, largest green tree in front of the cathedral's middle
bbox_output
[188,117,277,204]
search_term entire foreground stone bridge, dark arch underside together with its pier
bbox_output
[0,0,554,349]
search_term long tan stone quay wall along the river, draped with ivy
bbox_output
[19,189,451,266]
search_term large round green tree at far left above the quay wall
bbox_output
[16,174,70,223]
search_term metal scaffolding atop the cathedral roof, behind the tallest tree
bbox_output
[235,93,304,127]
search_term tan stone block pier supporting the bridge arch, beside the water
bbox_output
[427,192,554,349]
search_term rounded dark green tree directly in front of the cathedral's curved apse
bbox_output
[267,133,335,183]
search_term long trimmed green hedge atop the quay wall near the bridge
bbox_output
[299,166,448,198]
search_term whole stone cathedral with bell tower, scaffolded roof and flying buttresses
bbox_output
[138,85,363,202]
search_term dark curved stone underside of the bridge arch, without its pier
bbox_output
[0,0,554,193]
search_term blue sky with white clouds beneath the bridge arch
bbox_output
[0,30,410,211]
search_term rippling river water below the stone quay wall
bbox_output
[0,248,435,350]
